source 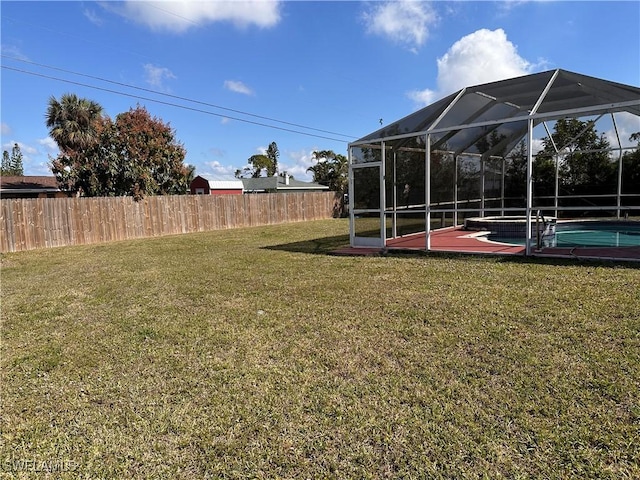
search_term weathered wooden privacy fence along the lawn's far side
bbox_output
[0,192,340,252]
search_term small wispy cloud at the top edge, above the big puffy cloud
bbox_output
[363,0,438,50]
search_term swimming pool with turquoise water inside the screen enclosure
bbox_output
[487,220,640,247]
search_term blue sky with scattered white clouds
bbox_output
[0,0,640,180]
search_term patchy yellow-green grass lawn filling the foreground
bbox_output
[0,220,640,479]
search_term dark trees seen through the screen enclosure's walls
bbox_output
[352,119,640,212]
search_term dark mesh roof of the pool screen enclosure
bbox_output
[351,69,640,155]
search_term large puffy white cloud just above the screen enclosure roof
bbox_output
[407,29,534,107]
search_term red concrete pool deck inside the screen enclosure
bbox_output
[333,227,640,261]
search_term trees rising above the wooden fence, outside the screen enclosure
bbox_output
[36,94,348,199]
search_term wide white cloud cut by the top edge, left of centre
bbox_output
[111,0,281,33]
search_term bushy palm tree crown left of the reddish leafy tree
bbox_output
[46,93,102,152]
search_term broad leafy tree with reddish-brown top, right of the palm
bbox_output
[52,106,194,199]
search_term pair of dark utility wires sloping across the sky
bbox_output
[0,54,356,141]
